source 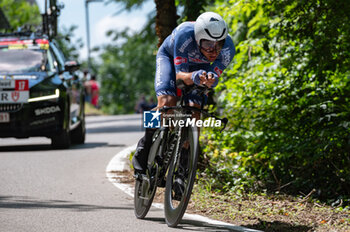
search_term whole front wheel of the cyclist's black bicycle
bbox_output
[164,127,199,227]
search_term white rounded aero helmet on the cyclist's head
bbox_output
[194,12,228,45]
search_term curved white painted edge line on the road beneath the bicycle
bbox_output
[106,144,261,232]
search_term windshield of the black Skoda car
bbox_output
[0,48,47,73]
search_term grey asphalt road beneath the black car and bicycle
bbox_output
[0,115,250,232]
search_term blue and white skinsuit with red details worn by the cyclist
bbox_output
[154,22,235,105]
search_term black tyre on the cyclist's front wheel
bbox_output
[164,127,199,227]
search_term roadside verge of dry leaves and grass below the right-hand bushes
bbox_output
[124,152,350,232]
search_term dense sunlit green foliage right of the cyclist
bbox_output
[203,0,350,203]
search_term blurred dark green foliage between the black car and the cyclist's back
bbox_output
[99,19,157,114]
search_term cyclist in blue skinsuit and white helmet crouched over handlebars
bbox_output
[133,12,235,180]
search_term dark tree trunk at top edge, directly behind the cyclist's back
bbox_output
[154,0,178,47]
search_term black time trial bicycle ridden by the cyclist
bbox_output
[134,81,228,227]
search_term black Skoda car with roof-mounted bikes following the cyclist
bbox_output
[0,34,85,148]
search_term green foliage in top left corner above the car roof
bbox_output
[0,0,41,29]
